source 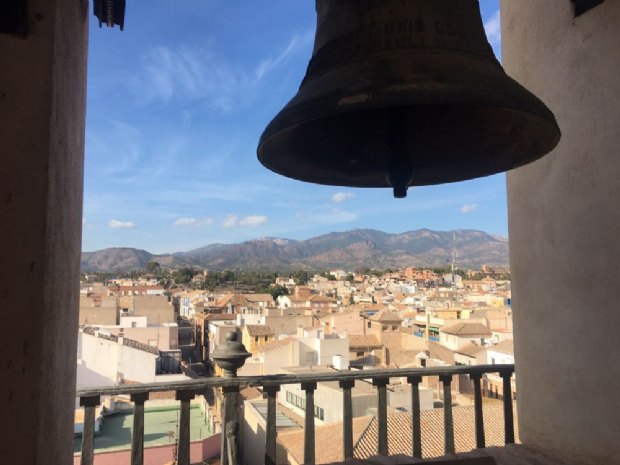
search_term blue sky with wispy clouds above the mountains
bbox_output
[82,0,507,253]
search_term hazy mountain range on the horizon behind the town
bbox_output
[82,229,508,271]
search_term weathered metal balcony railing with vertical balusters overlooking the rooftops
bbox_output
[77,352,515,465]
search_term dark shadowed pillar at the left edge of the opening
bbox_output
[0,0,88,464]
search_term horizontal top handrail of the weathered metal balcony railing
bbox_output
[76,364,514,398]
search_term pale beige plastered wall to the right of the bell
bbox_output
[501,0,620,464]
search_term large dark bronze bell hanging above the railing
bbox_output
[258,0,560,197]
